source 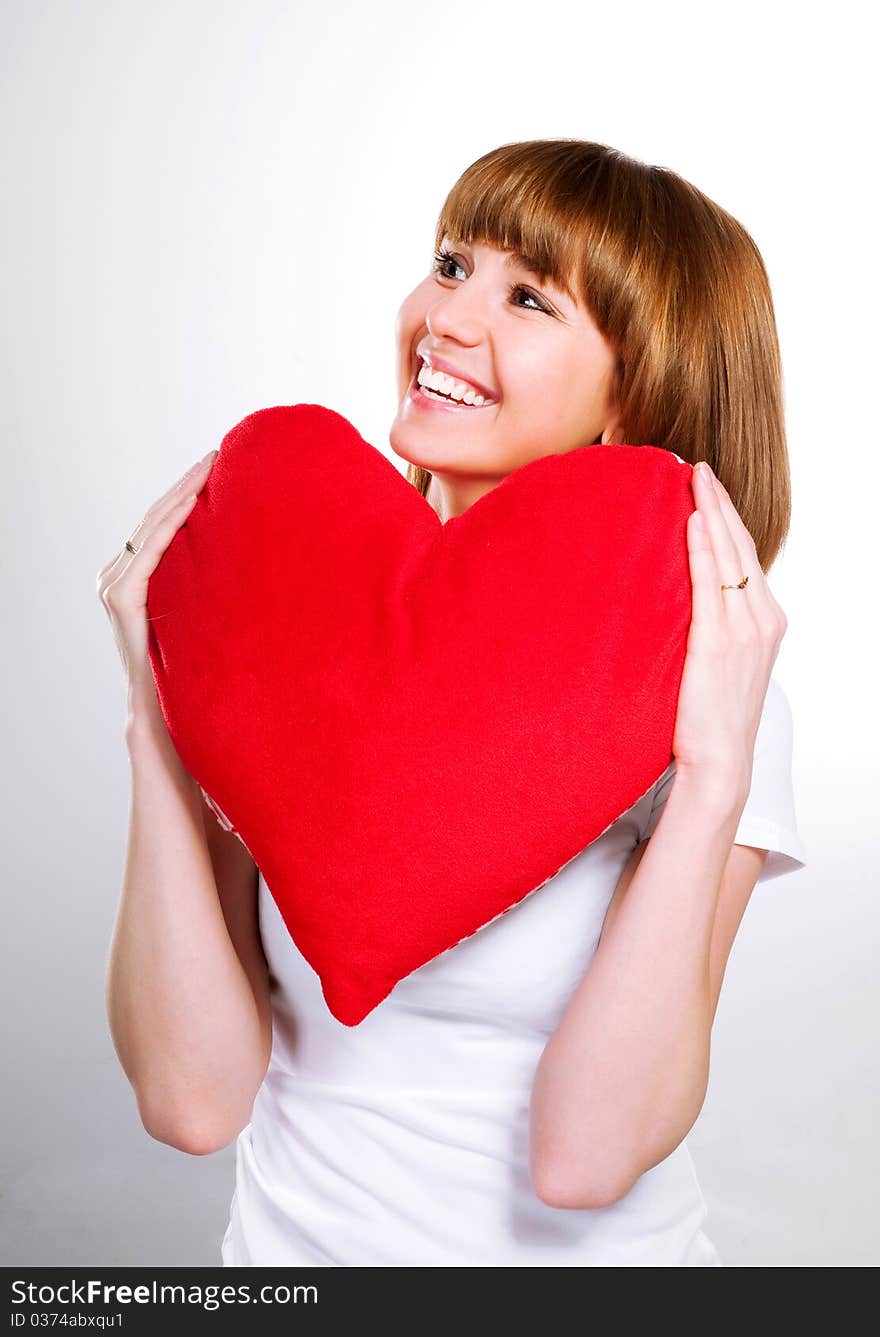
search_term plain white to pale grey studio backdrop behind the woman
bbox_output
[0,0,880,1266]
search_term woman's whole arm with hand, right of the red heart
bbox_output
[530,465,788,1207]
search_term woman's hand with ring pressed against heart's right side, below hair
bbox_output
[673,465,788,801]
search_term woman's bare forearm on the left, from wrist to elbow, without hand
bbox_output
[106,689,263,1148]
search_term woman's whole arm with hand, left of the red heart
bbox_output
[96,451,271,1154]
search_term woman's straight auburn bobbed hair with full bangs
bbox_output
[407,139,792,572]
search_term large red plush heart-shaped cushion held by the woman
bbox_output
[147,404,694,1025]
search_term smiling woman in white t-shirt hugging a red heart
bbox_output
[99,140,804,1266]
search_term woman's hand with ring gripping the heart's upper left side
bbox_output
[98,451,218,701]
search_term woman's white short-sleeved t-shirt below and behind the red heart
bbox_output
[221,679,806,1267]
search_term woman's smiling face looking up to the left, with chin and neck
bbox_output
[391,238,618,521]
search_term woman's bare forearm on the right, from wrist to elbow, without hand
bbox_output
[531,775,745,1206]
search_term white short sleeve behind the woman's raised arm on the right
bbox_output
[639,678,806,882]
